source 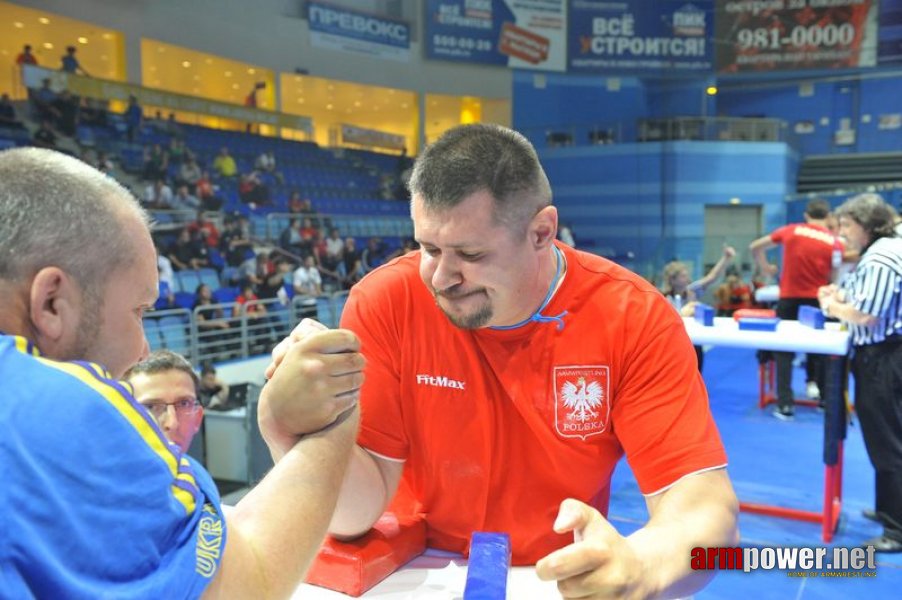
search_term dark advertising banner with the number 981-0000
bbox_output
[715,0,878,73]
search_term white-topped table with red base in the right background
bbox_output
[683,317,849,542]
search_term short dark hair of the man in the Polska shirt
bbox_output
[408,123,551,230]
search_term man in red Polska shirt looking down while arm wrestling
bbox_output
[277,124,737,597]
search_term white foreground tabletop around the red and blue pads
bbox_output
[293,550,561,600]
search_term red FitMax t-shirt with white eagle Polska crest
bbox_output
[342,245,726,564]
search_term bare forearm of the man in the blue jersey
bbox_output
[214,410,359,598]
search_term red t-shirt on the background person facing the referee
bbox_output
[770,223,843,298]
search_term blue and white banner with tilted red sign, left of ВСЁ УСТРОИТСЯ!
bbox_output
[423,0,567,71]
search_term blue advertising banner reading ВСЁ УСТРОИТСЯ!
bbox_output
[569,0,714,74]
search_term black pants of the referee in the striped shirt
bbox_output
[852,338,902,541]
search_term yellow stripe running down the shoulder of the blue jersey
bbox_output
[36,356,197,515]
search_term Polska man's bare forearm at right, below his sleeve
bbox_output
[627,472,739,598]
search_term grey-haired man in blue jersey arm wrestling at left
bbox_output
[0,148,363,598]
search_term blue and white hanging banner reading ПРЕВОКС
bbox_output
[307,2,410,62]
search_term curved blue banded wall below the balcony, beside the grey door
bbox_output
[539,141,798,276]
